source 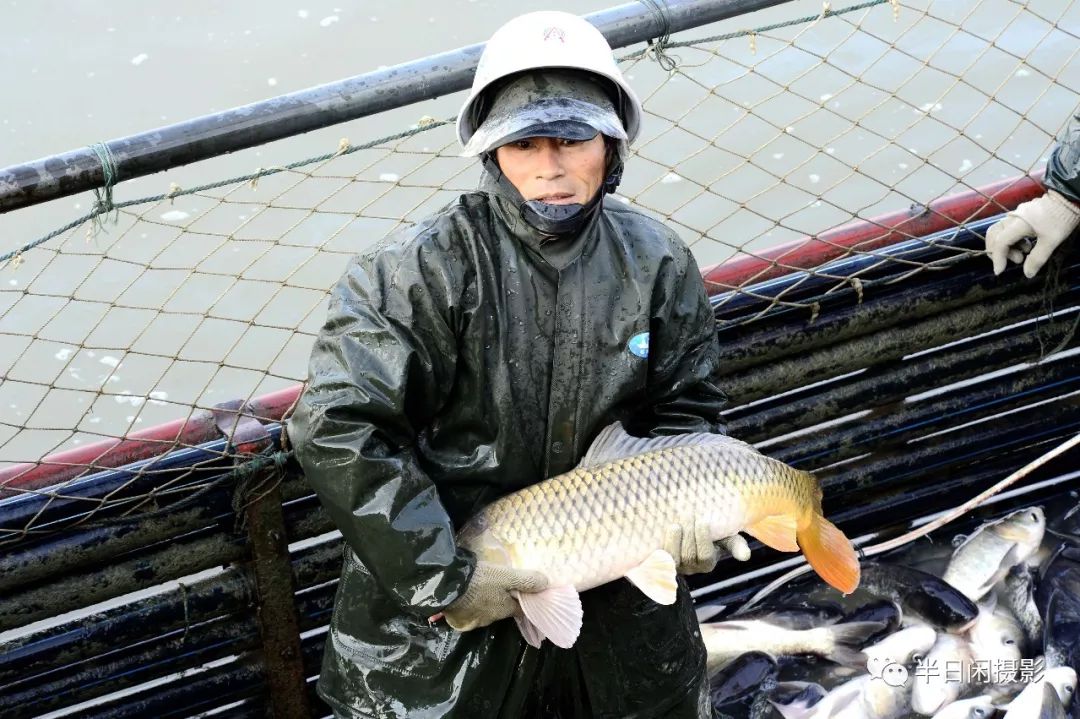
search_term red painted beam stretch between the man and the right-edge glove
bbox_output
[701,171,1044,295]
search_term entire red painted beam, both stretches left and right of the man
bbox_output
[0,172,1043,497]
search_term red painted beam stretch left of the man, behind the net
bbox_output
[0,384,301,497]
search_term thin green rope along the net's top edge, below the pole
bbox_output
[0,0,891,264]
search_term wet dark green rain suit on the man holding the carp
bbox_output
[288,164,725,719]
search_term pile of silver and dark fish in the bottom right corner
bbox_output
[699,507,1080,719]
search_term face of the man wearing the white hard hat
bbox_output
[495,135,606,205]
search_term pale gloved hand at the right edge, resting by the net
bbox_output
[986,190,1080,277]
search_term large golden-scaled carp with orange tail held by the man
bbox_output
[446,423,860,647]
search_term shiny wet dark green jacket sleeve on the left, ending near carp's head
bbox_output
[289,239,474,614]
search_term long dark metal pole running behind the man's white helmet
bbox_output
[0,0,791,213]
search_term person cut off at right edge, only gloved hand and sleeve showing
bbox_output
[986,111,1080,277]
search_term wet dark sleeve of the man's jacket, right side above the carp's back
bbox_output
[632,241,727,436]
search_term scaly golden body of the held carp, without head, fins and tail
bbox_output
[465,445,816,591]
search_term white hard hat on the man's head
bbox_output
[458,10,642,146]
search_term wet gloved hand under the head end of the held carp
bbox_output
[436,561,548,632]
